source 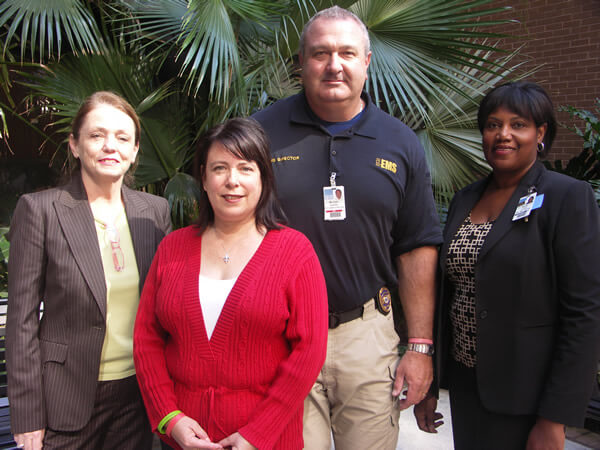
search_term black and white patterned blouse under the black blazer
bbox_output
[446,214,494,367]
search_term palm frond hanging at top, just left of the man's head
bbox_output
[121,0,290,102]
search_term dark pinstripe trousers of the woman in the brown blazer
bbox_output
[44,375,152,450]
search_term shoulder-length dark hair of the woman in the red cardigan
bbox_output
[194,118,286,230]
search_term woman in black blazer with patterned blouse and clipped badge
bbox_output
[415,82,600,450]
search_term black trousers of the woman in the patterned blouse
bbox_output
[449,362,536,450]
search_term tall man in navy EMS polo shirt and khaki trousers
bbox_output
[254,6,442,450]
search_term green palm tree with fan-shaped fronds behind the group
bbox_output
[0,0,516,225]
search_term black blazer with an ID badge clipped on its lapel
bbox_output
[437,162,600,426]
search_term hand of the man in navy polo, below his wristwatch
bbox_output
[392,351,433,410]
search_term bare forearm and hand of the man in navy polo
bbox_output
[392,246,438,409]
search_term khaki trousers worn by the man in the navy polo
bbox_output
[304,300,400,450]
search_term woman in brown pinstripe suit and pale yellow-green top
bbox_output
[6,92,171,449]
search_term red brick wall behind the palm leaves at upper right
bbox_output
[491,0,600,160]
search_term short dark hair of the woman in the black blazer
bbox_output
[477,81,557,156]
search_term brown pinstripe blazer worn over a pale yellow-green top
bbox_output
[6,175,171,433]
